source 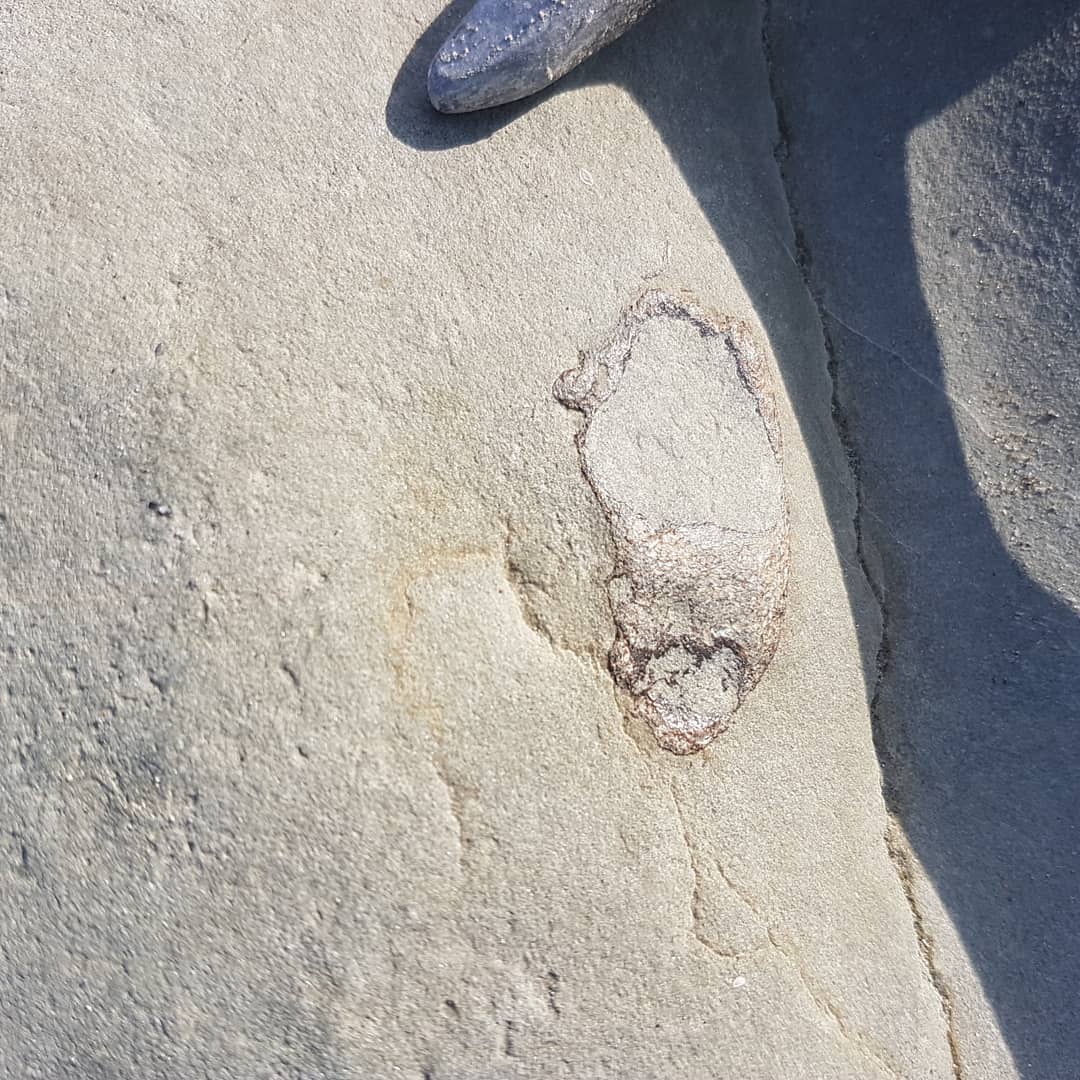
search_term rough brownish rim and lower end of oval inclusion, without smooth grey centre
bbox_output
[553,289,789,754]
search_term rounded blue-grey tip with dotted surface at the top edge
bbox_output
[428,0,656,112]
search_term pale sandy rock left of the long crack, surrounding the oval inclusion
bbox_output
[0,0,951,1080]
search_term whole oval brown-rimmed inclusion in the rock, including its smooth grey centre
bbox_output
[554,289,788,754]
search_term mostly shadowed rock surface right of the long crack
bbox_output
[767,0,1080,1080]
